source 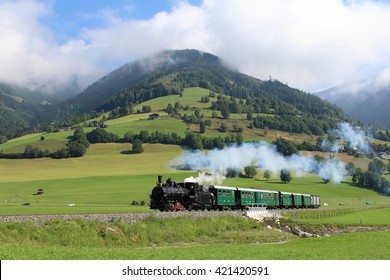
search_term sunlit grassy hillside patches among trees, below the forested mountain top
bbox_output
[0,87,304,153]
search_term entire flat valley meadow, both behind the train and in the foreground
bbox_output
[0,141,390,259]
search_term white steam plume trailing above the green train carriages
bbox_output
[173,142,346,183]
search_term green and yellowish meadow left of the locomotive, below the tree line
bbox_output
[0,144,194,214]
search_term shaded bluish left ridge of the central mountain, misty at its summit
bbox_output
[42,50,230,120]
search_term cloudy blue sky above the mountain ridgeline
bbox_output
[0,0,390,92]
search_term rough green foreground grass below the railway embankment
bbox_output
[0,217,390,260]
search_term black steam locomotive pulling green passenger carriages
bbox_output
[150,175,320,212]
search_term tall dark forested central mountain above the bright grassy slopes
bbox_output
[45,50,348,131]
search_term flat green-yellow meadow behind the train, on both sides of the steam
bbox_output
[0,143,390,214]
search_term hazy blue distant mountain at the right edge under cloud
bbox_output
[315,77,390,130]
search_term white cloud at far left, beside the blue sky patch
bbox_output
[0,0,102,91]
